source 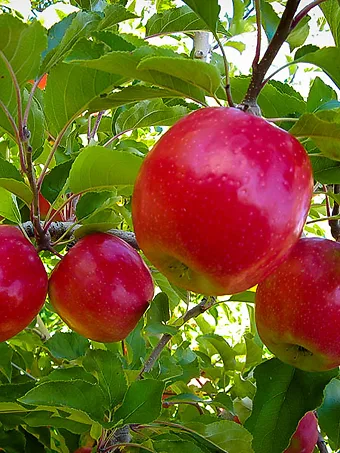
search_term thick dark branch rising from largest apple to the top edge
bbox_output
[241,0,300,114]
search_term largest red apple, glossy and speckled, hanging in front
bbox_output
[132,107,312,295]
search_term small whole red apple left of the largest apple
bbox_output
[49,233,154,343]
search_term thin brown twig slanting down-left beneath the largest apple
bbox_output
[137,297,216,380]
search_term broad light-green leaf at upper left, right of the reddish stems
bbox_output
[44,60,123,136]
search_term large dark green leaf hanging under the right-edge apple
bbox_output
[245,359,338,453]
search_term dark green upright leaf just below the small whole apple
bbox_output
[83,349,127,409]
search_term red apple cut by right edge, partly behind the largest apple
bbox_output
[255,238,340,371]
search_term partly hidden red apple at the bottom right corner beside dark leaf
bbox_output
[284,412,318,453]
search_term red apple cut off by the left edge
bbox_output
[0,225,48,341]
